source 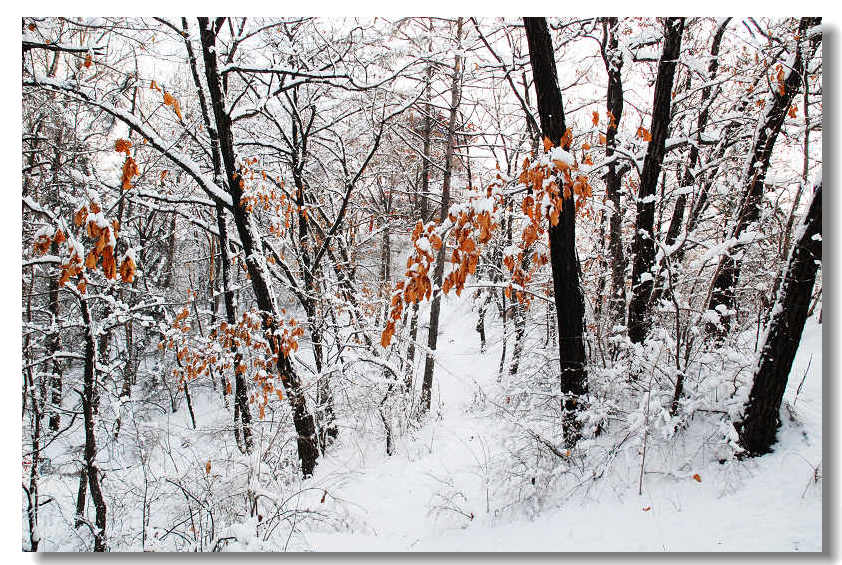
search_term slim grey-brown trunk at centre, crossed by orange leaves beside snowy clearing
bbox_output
[420,18,462,414]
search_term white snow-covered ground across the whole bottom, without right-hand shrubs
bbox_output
[23,296,822,551]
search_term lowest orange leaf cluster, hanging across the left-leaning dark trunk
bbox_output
[158,307,304,418]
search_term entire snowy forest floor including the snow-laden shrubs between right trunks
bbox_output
[24,297,822,551]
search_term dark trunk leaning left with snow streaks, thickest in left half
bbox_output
[199,17,319,478]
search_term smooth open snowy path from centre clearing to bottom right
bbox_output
[298,304,822,551]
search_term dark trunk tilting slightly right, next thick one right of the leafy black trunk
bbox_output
[628,18,684,343]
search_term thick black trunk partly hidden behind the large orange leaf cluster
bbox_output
[523,18,587,447]
